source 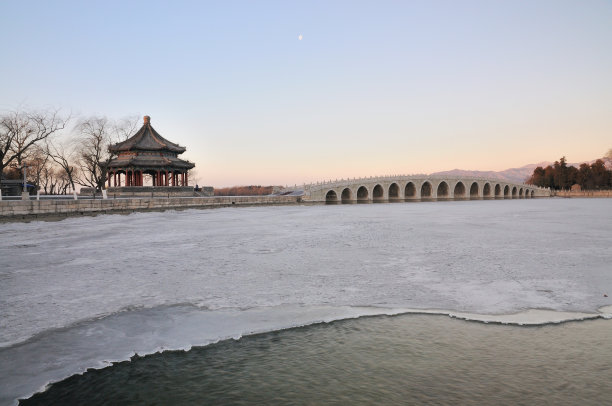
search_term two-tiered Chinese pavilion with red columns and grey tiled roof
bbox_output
[107,116,195,188]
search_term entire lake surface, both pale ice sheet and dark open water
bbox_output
[0,199,612,405]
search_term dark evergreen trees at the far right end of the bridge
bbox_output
[527,155,612,190]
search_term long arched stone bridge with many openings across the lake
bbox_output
[294,175,551,203]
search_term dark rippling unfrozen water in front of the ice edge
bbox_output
[21,315,612,405]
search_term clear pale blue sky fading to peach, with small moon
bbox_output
[0,0,612,187]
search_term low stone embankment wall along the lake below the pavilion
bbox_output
[0,196,302,221]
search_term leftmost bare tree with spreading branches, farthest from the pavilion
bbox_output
[0,111,70,177]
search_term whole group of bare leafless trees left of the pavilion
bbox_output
[0,110,138,194]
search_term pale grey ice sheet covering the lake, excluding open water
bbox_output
[0,199,612,404]
